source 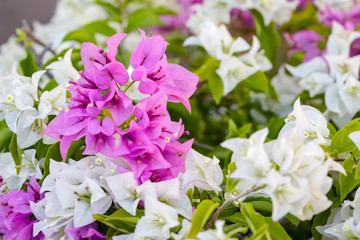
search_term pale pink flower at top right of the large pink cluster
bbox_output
[130,30,199,111]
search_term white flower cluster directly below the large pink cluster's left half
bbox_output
[30,157,116,240]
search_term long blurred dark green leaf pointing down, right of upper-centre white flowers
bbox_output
[251,10,281,65]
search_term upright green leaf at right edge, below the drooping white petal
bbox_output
[340,158,360,201]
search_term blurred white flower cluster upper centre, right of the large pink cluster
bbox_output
[184,19,272,95]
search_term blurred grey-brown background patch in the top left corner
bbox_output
[0,0,56,44]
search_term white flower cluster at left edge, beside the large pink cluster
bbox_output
[0,49,80,149]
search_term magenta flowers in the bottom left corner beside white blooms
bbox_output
[0,176,44,240]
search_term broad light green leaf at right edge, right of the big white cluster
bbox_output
[330,118,360,153]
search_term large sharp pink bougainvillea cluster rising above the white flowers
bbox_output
[45,30,198,183]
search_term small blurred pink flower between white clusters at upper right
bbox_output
[284,30,325,62]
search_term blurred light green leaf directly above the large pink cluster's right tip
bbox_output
[125,8,168,33]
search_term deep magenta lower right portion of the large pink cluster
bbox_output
[118,91,192,183]
